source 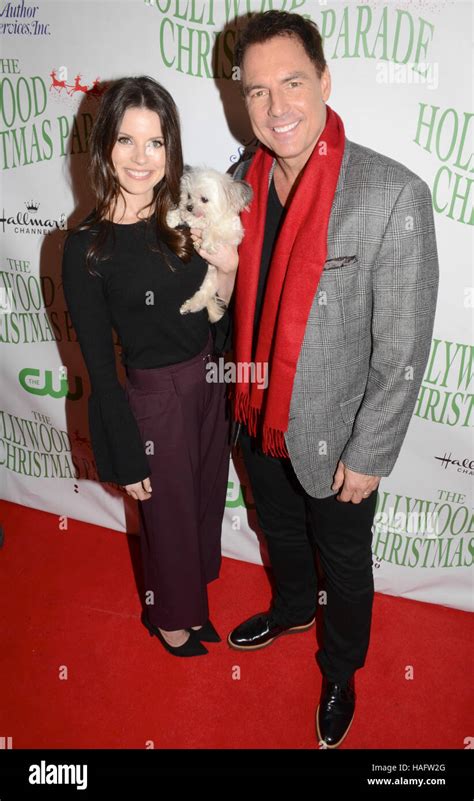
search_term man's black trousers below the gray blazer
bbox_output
[239,426,377,682]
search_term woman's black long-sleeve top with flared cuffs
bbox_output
[62,212,230,485]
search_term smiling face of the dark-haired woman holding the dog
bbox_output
[112,108,166,203]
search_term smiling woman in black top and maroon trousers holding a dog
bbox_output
[62,76,238,656]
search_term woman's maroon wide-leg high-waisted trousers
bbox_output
[125,335,230,631]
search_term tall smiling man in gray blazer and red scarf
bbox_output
[224,11,438,748]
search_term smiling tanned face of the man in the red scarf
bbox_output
[241,35,331,169]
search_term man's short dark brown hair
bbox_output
[234,11,326,78]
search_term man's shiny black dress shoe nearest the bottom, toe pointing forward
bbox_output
[316,676,356,748]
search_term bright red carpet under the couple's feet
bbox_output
[0,503,472,750]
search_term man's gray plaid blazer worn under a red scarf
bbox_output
[234,139,439,498]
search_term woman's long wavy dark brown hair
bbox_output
[67,75,194,273]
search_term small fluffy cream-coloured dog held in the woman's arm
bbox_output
[167,167,253,323]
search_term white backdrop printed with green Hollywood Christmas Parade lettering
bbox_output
[0,0,474,609]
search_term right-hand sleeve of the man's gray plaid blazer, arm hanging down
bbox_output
[341,178,439,476]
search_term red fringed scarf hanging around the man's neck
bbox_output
[233,105,345,456]
